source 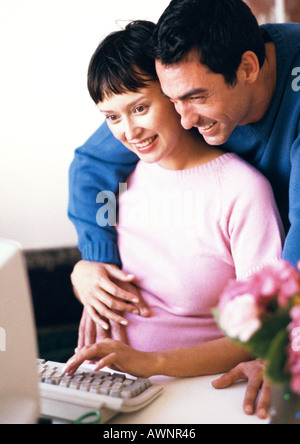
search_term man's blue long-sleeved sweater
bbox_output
[69,23,300,266]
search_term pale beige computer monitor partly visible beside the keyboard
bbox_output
[0,238,39,424]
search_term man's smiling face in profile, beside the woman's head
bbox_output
[156,52,251,145]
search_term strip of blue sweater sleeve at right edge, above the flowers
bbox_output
[283,127,300,266]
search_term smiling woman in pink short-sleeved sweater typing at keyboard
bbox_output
[67,22,283,377]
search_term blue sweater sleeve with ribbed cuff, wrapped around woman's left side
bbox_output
[68,123,138,266]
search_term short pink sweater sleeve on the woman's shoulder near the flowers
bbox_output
[224,158,284,280]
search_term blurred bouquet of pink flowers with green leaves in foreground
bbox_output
[215,261,300,424]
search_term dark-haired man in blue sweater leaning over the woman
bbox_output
[69,0,300,417]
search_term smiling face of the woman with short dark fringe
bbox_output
[98,82,185,163]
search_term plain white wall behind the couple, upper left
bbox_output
[0,0,169,249]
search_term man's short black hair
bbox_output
[154,0,265,85]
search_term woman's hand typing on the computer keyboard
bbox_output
[65,339,157,378]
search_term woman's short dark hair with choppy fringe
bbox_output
[88,21,157,103]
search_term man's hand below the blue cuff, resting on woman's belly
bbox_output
[71,261,150,330]
